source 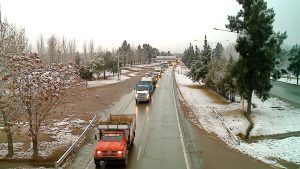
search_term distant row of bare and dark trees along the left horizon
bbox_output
[36,35,171,69]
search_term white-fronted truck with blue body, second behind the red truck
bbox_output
[135,77,154,103]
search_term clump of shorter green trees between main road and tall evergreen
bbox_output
[182,36,235,101]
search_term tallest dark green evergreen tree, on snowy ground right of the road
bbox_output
[226,0,287,113]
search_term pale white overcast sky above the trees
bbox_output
[0,0,300,52]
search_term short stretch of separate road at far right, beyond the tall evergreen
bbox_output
[270,81,300,105]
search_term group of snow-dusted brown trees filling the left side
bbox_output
[0,16,86,158]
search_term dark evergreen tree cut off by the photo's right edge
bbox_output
[288,44,300,84]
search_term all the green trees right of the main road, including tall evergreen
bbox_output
[182,0,300,113]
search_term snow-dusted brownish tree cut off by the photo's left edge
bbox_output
[0,17,28,157]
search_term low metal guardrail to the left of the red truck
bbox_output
[54,115,97,169]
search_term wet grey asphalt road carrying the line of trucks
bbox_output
[68,68,271,169]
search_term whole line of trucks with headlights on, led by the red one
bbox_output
[94,63,172,167]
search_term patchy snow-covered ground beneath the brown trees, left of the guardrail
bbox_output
[0,118,89,159]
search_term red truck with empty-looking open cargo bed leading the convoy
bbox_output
[94,114,136,167]
